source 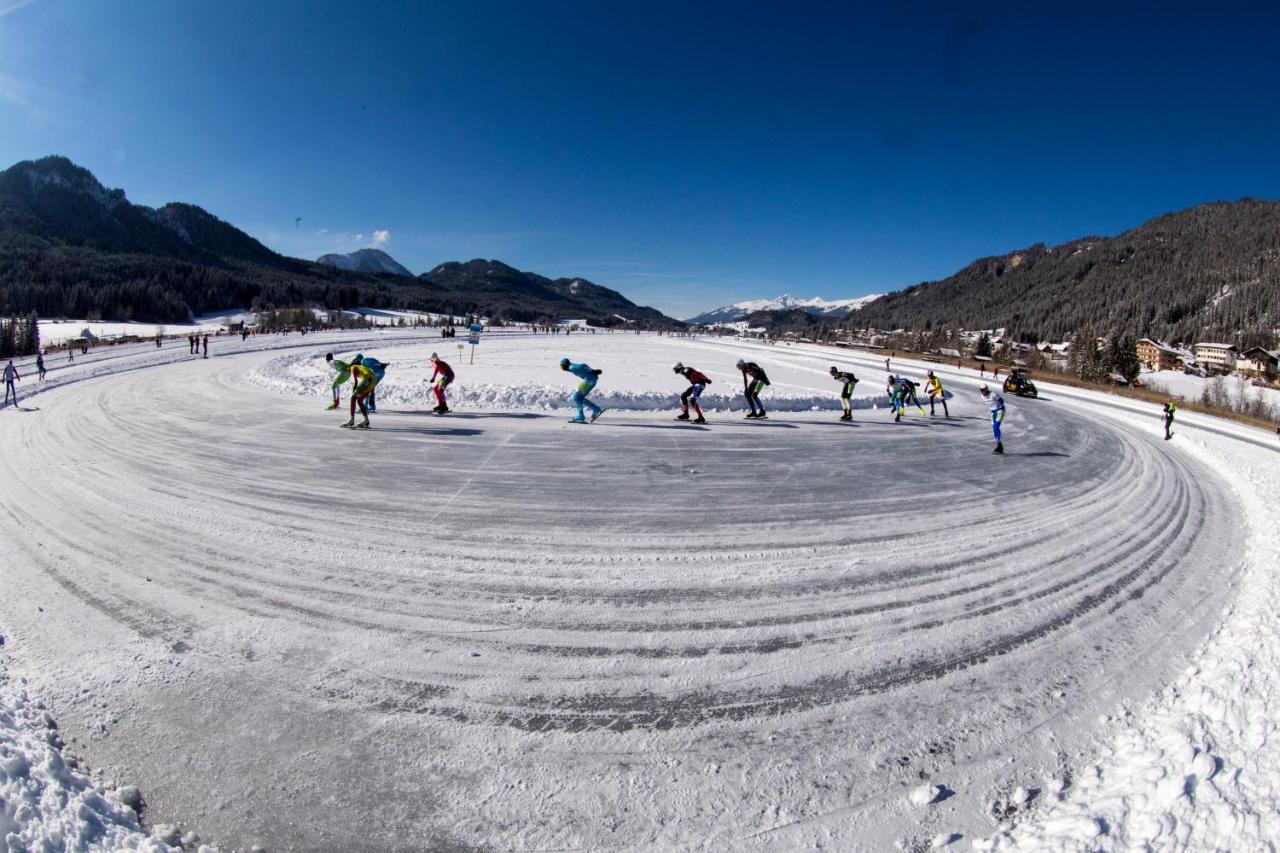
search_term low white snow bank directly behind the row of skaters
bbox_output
[247,336,888,412]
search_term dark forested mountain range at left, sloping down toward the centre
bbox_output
[0,156,681,329]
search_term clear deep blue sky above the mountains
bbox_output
[0,0,1280,316]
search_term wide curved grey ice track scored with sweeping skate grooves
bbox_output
[0,340,1238,848]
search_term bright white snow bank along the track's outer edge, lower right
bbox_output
[974,428,1280,850]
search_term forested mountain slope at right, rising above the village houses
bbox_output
[850,199,1280,347]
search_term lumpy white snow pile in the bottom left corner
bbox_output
[0,671,172,853]
